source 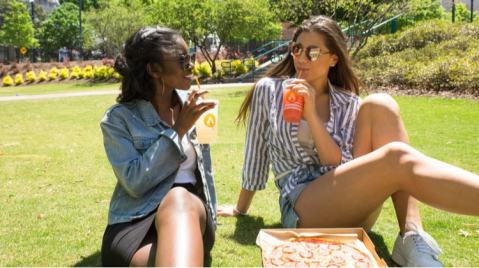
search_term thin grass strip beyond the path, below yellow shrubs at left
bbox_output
[0,81,120,97]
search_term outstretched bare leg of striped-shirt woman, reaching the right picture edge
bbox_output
[295,139,479,227]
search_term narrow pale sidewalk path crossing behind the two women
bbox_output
[0,83,253,102]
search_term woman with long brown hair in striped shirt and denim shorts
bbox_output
[218,16,479,266]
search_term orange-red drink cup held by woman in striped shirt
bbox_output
[282,78,304,123]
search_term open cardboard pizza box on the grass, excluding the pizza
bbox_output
[256,228,387,267]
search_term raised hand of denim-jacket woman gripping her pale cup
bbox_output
[173,90,216,137]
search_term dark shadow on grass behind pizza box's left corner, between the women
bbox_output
[229,215,281,245]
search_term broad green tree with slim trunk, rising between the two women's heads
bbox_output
[150,0,281,73]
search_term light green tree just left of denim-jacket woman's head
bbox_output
[87,0,148,57]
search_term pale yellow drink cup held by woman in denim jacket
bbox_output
[195,100,219,144]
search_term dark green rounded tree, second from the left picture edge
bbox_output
[38,3,91,58]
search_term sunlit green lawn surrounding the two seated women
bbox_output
[0,85,479,266]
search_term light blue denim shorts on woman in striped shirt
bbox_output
[275,173,314,228]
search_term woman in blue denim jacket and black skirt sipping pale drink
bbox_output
[101,27,216,266]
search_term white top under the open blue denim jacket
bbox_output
[175,134,196,184]
